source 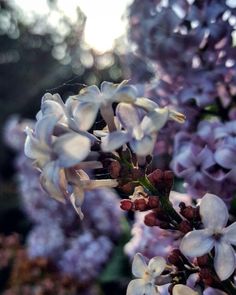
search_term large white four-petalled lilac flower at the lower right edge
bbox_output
[180,194,236,281]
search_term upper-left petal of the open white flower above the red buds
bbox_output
[116,103,140,132]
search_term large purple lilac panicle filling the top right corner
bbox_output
[129,0,236,108]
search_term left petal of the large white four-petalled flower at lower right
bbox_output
[180,229,214,257]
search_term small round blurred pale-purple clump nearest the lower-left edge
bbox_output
[27,224,66,259]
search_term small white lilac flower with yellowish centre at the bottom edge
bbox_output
[126,253,166,295]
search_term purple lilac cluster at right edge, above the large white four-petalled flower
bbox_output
[171,121,236,200]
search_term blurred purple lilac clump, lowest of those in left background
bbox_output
[58,231,113,283]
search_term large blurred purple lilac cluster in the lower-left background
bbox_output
[5,117,122,285]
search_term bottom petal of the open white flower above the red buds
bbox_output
[130,135,156,156]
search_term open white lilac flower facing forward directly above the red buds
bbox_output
[102,103,184,156]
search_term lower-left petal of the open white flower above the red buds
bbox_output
[101,131,129,152]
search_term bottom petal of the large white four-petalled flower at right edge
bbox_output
[214,241,236,281]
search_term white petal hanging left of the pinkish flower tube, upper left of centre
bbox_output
[73,102,99,131]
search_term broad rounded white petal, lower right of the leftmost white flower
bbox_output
[53,133,91,168]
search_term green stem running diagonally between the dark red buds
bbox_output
[138,176,182,223]
